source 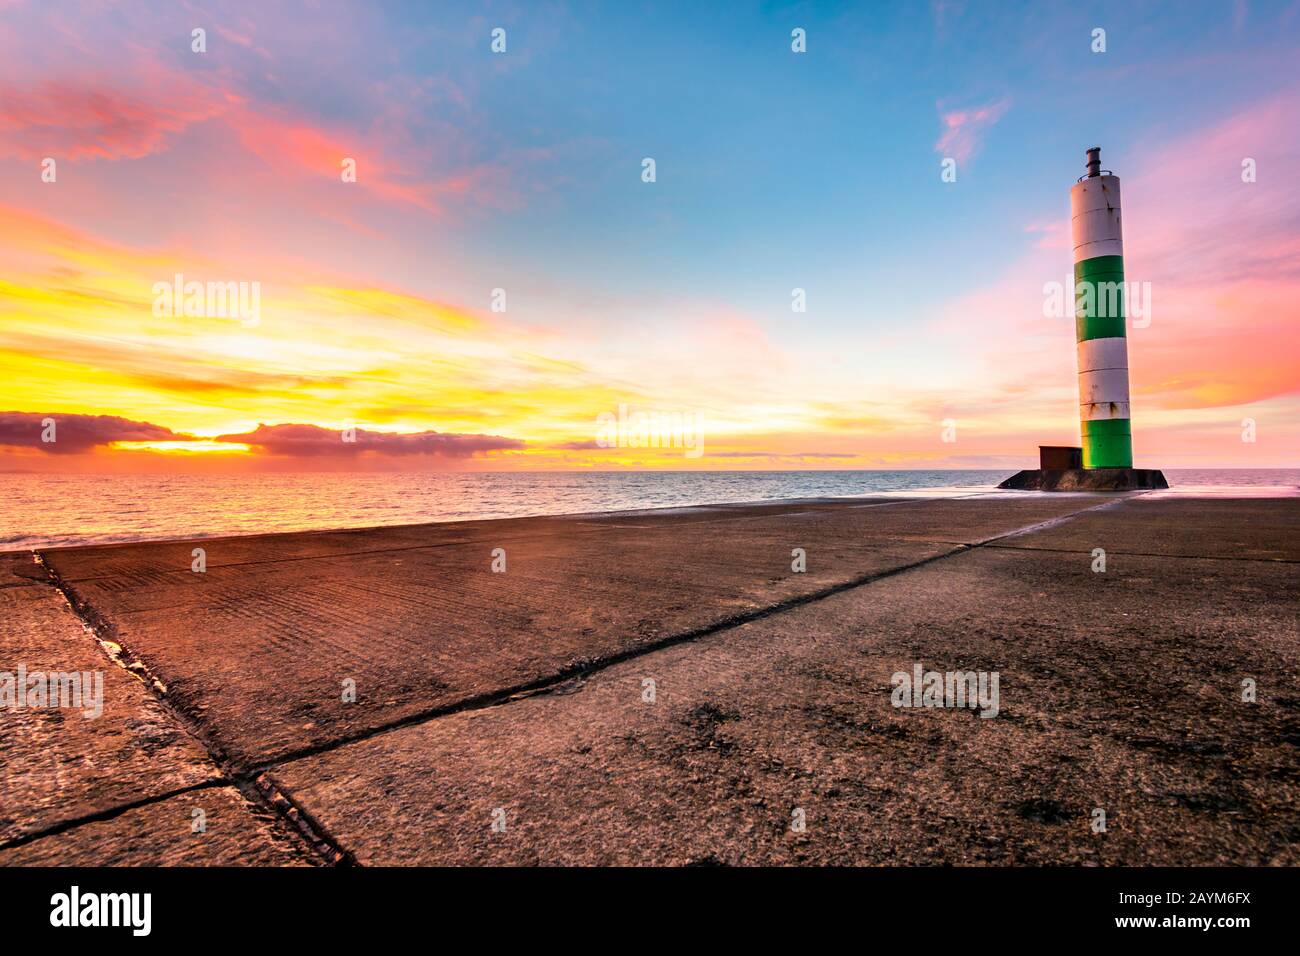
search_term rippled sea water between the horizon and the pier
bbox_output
[0,470,1300,550]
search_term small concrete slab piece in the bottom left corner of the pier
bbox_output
[0,787,315,866]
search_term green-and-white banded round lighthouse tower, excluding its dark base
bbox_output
[1070,146,1134,468]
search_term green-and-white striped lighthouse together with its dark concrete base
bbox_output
[998,146,1169,492]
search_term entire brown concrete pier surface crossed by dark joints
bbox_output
[0,494,1300,865]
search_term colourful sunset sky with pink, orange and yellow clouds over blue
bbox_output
[0,0,1300,472]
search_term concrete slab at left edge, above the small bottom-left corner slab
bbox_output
[0,582,217,844]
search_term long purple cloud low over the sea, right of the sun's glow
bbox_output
[215,424,524,458]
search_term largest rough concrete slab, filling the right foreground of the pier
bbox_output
[272,538,1300,865]
